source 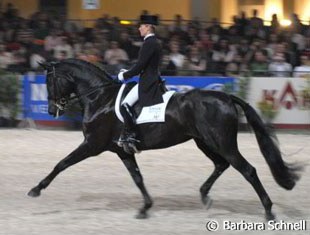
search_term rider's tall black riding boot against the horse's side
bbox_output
[118,103,139,153]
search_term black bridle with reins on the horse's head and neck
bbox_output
[46,64,119,118]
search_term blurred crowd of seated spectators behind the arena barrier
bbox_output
[0,4,310,77]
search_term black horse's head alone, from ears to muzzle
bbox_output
[39,62,74,117]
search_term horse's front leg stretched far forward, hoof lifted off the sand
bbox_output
[28,142,92,197]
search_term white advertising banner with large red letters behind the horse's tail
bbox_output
[248,77,310,128]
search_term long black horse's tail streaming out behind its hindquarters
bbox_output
[231,95,301,190]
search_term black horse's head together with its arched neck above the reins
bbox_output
[40,59,120,116]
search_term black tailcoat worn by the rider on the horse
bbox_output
[124,36,163,106]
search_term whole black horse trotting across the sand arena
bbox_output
[28,59,299,220]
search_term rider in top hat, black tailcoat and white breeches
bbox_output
[118,15,163,151]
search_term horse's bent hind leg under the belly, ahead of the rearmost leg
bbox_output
[195,139,229,205]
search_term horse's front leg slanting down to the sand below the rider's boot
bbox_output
[118,152,153,219]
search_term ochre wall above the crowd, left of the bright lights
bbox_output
[1,0,191,20]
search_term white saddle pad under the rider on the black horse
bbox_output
[115,84,175,124]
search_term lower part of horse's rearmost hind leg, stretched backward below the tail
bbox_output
[226,150,275,220]
